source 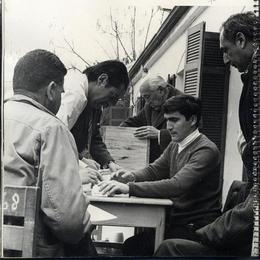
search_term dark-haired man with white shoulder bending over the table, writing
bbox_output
[57,60,129,184]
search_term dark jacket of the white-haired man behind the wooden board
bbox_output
[120,88,180,163]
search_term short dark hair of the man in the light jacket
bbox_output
[13,49,67,93]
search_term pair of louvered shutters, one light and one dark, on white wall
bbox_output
[184,23,229,177]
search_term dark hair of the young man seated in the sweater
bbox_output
[163,94,202,126]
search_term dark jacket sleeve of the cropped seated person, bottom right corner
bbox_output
[196,189,253,256]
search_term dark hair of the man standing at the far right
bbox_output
[220,12,259,43]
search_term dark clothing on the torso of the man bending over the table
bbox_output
[71,102,113,165]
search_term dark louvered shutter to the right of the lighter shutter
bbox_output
[200,32,229,154]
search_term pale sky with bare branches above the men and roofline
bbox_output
[3,0,253,95]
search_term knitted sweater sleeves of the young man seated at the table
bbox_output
[129,145,220,198]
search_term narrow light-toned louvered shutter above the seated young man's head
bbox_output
[184,22,205,97]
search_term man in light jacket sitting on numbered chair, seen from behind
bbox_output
[3,49,95,257]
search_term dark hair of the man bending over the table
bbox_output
[83,60,129,90]
